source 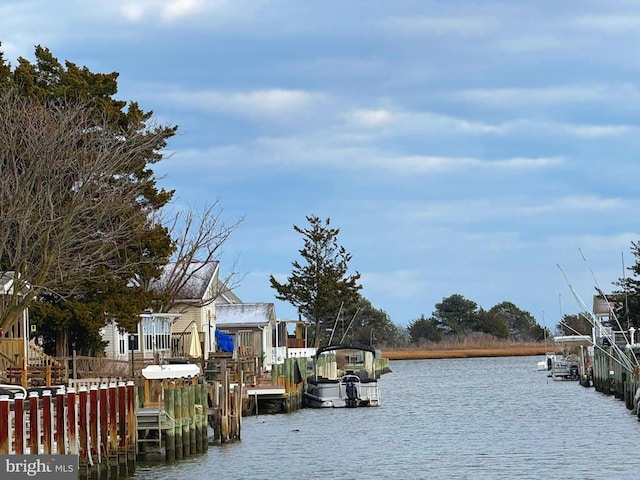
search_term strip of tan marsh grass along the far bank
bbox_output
[382,339,553,360]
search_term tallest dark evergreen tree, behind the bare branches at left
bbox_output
[0,46,177,355]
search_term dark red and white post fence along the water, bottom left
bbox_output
[0,382,136,477]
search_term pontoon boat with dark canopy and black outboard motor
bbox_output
[304,344,380,408]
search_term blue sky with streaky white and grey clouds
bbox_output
[0,0,640,330]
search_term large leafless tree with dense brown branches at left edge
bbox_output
[0,91,172,330]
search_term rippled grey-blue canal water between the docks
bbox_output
[127,357,640,480]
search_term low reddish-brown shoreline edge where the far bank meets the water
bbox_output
[382,345,549,360]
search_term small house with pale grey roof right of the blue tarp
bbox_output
[216,303,287,370]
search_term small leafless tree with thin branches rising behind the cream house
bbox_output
[147,200,244,312]
